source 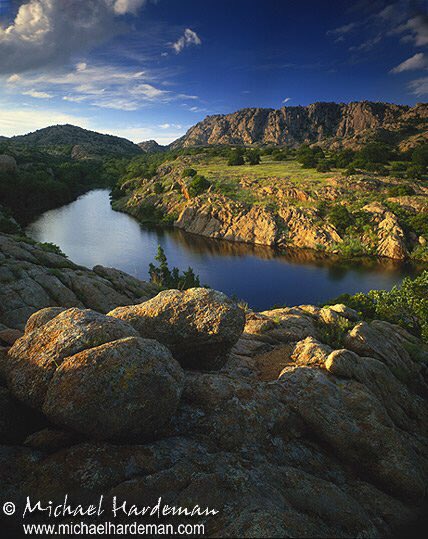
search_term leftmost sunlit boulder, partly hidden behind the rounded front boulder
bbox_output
[6,308,137,410]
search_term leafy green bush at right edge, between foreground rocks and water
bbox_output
[329,271,428,342]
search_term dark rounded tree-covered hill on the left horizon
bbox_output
[9,124,142,158]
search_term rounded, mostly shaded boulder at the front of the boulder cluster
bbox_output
[43,337,184,439]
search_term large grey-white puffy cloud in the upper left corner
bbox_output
[0,0,145,73]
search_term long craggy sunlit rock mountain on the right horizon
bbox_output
[170,101,428,149]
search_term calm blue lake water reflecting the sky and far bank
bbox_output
[27,189,417,310]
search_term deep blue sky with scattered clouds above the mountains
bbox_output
[0,0,428,144]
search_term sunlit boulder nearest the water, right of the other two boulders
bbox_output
[108,288,245,370]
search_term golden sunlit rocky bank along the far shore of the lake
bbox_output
[112,158,428,261]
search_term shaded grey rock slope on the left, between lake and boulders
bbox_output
[0,234,158,329]
